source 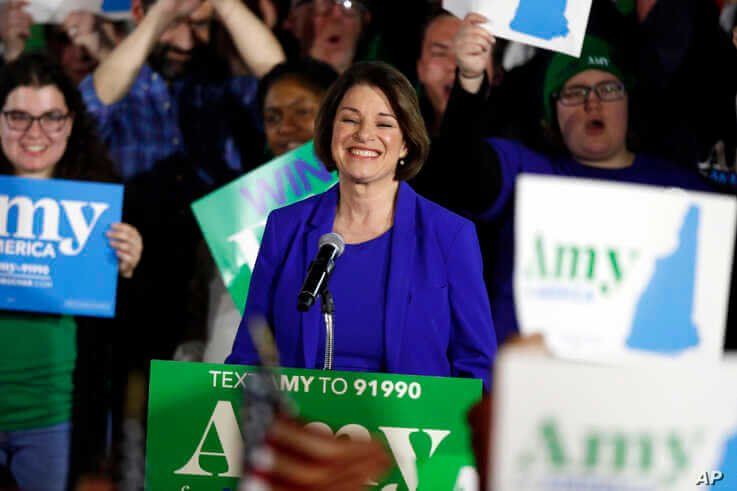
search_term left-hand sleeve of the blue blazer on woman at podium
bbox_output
[225,214,280,365]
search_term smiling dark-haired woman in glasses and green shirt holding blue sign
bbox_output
[0,55,143,491]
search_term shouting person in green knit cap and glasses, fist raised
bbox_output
[421,14,709,343]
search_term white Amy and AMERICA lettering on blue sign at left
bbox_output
[0,195,108,257]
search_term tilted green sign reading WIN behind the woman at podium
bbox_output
[192,142,338,313]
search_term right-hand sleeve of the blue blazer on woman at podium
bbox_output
[446,222,497,391]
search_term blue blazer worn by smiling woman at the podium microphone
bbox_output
[226,183,496,390]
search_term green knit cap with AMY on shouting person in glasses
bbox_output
[543,36,627,124]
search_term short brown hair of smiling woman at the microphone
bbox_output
[315,61,430,181]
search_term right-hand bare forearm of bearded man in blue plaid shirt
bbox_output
[210,0,285,78]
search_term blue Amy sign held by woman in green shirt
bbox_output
[0,176,123,317]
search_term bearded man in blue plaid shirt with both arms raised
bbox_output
[80,0,284,182]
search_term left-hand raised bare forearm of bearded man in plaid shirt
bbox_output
[93,0,202,105]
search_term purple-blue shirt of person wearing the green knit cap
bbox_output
[476,138,713,344]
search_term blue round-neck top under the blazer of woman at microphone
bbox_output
[317,229,392,372]
